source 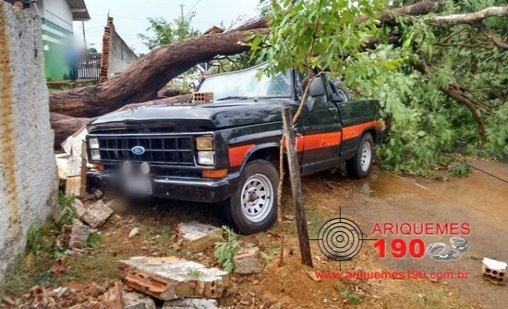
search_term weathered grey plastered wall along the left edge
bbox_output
[0,1,58,281]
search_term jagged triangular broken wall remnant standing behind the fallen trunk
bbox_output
[100,17,138,82]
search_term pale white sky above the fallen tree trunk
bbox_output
[73,0,259,54]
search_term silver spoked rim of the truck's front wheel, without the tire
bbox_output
[241,174,274,222]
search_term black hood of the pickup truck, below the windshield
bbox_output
[89,99,293,130]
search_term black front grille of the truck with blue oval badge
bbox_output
[90,135,195,166]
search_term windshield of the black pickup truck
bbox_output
[198,67,291,101]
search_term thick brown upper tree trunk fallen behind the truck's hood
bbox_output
[50,29,268,117]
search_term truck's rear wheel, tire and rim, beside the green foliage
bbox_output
[346,133,374,179]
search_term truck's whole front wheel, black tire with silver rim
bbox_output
[223,160,279,235]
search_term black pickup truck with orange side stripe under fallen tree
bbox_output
[87,66,384,234]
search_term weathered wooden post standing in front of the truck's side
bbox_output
[282,107,313,267]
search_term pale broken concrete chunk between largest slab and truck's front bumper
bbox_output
[176,221,222,252]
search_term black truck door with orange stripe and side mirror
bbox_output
[299,75,342,175]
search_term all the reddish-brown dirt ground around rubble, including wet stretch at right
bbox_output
[0,162,508,308]
